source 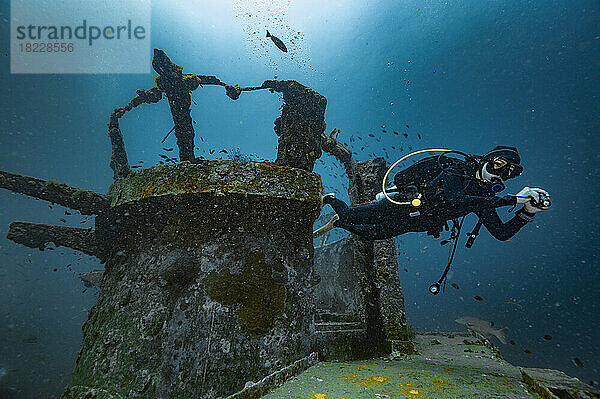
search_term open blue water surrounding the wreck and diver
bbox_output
[0,0,600,397]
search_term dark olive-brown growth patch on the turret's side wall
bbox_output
[204,252,285,335]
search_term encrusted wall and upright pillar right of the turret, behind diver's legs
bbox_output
[314,157,412,359]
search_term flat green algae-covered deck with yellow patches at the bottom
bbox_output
[264,333,534,399]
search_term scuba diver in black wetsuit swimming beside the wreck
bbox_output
[313,146,551,294]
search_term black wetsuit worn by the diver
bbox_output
[326,157,531,241]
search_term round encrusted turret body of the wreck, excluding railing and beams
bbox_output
[65,161,320,398]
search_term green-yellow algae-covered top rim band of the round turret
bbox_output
[108,160,322,207]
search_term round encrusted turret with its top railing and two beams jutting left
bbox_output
[0,50,326,398]
